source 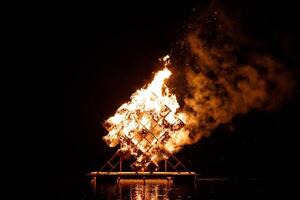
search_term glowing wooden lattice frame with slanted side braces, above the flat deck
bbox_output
[100,103,188,172]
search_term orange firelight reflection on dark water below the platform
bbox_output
[96,179,193,200]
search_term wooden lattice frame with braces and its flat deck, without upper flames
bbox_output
[90,102,196,177]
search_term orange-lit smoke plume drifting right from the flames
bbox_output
[172,7,295,144]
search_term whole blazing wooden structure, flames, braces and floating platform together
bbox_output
[88,57,198,191]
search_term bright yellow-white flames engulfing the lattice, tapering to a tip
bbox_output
[103,56,188,171]
